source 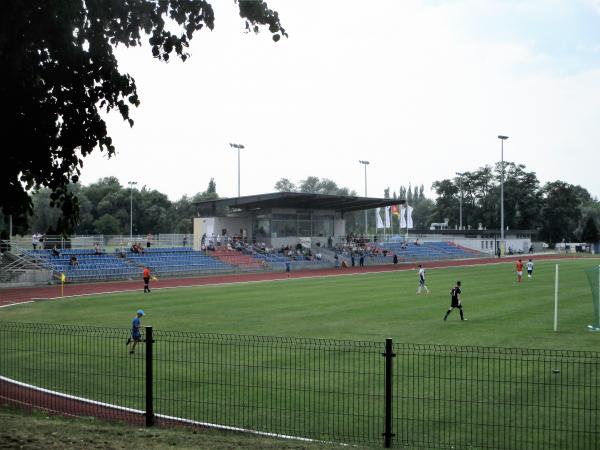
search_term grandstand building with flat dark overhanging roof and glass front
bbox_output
[194,192,404,250]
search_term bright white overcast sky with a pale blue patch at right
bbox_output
[81,0,600,200]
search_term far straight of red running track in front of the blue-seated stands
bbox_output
[0,255,575,307]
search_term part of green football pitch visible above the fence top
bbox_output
[0,255,600,351]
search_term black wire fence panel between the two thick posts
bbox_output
[154,330,384,444]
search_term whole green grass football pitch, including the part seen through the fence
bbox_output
[0,259,600,449]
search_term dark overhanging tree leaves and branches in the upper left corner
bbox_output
[0,0,287,224]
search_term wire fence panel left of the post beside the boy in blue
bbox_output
[0,322,145,423]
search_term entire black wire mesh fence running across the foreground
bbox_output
[0,322,600,449]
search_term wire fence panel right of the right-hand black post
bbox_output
[394,344,600,450]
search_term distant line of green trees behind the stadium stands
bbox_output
[0,162,600,244]
